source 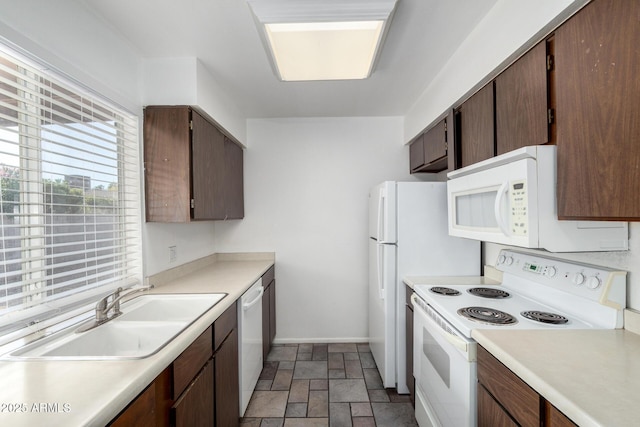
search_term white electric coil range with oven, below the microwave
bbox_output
[412,250,626,427]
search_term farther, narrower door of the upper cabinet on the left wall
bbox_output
[224,137,244,219]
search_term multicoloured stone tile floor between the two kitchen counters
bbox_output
[240,344,418,427]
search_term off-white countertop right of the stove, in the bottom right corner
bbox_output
[472,329,640,427]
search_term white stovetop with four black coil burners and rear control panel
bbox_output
[413,249,627,338]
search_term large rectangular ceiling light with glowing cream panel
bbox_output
[248,0,396,81]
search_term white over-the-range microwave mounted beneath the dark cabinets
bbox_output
[447,145,629,252]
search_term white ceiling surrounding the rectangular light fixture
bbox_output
[83,0,497,118]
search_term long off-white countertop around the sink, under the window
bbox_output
[0,253,275,427]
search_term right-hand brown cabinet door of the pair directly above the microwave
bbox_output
[495,41,549,154]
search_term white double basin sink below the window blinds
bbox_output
[8,293,226,360]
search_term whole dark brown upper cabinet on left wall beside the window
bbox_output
[144,106,244,222]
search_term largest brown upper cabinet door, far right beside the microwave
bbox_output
[554,0,640,220]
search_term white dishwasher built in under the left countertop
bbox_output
[238,278,264,416]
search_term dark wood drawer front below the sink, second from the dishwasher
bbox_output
[173,326,213,400]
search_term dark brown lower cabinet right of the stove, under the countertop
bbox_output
[478,346,575,427]
